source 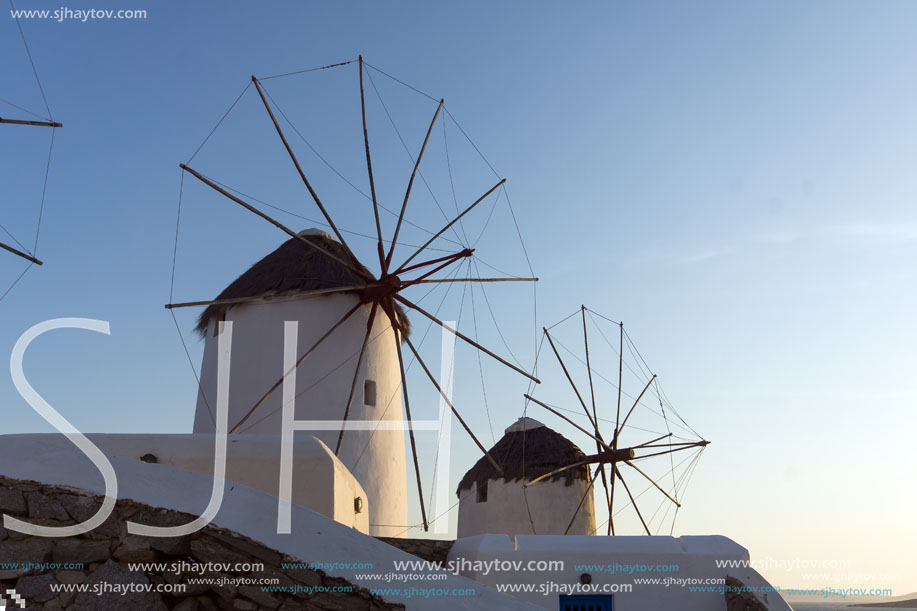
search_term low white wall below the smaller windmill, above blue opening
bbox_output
[449,534,792,611]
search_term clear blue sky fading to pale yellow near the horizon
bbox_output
[0,0,917,594]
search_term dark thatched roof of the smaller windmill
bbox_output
[456,418,589,496]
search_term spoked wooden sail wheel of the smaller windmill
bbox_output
[523,306,709,535]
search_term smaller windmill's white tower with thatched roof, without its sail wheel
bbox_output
[457,418,595,538]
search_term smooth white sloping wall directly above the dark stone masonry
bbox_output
[0,436,538,611]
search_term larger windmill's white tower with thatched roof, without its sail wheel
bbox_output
[194,229,407,536]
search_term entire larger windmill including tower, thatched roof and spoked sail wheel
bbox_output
[165,58,539,536]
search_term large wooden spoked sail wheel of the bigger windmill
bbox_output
[165,57,538,530]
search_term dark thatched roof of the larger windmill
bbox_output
[195,229,411,335]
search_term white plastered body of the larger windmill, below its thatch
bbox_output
[194,294,408,536]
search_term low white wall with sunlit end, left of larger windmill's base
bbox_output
[0,434,369,533]
